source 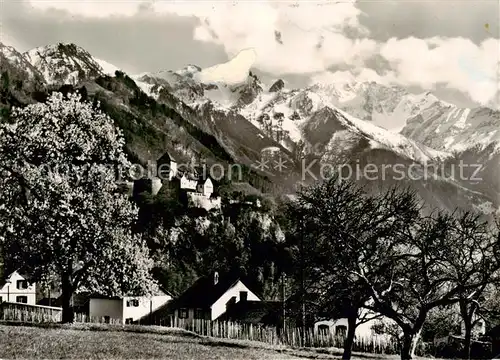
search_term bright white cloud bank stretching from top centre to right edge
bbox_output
[153,1,500,105]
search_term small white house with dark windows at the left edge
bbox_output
[0,271,36,305]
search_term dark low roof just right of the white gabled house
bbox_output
[221,301,283,325]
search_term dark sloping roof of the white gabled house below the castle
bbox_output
[174,275,252,308]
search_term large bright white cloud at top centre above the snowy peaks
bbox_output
[172,2,376,76]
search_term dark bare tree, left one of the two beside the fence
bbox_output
[289,177,419,359]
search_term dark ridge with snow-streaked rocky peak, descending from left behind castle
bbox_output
[0,45,282,197]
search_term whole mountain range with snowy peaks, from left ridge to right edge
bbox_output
[5,40,500,212]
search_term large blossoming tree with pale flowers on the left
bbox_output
[0,93,155,322]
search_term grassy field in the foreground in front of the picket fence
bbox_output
[0,325,424,360]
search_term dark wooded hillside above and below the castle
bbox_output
[0,49,292,298]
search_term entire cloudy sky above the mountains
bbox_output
[0,0,500,108]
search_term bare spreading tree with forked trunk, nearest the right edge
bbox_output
[358,212,495,360]
